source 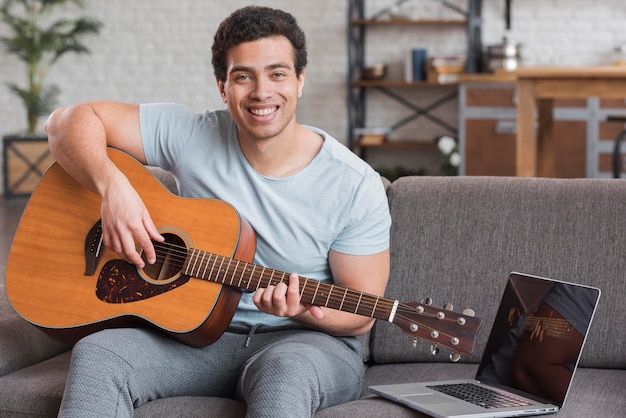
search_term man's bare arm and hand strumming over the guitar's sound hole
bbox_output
[46,102,158,267]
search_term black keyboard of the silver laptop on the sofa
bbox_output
[427,383,530,408]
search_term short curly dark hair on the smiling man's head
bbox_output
[212,6,307,82]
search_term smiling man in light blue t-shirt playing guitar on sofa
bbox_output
[46,7,390,418]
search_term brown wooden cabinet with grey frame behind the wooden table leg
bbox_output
[459,82,626,178]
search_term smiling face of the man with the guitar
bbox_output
[218,37,304,140]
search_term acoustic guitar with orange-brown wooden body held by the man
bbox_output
[6,149,480,359]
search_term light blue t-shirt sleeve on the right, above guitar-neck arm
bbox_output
[331,171,391,255]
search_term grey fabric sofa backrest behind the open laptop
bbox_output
[370,177,626,368]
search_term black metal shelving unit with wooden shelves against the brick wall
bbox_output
[347,0,482,164]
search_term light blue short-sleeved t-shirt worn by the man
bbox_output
[140,104,391,326]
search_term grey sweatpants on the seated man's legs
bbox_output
[59,329,364,418]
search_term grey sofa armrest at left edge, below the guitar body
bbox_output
[0,285,70,376]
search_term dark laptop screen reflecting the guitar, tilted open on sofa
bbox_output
[476,273,600,406]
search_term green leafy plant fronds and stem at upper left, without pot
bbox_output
[0,0,101,135]
